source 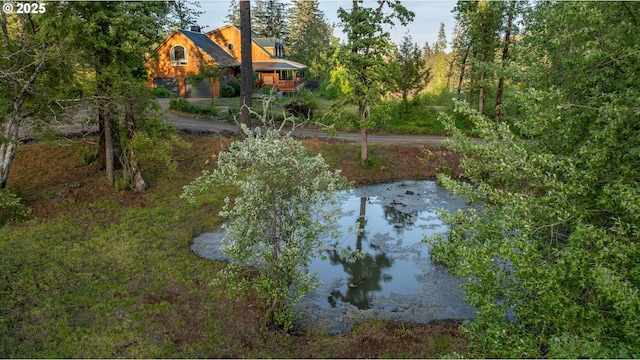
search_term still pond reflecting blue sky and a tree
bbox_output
[192,181,474,333]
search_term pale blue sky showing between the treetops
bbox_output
[198,0,456,48]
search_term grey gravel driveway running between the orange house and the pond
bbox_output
[158,99,446,145]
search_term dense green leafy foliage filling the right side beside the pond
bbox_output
[432,2,640,358]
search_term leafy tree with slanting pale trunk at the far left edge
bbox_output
[0,3,73,188]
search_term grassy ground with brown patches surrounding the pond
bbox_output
[0,136,467,358]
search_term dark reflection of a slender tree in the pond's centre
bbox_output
[327,197,393,309]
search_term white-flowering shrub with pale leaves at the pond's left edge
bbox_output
[183,128,348,330]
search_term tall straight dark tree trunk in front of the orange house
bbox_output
[238,0,253,139]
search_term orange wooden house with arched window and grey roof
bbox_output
[147,25,307,98]
